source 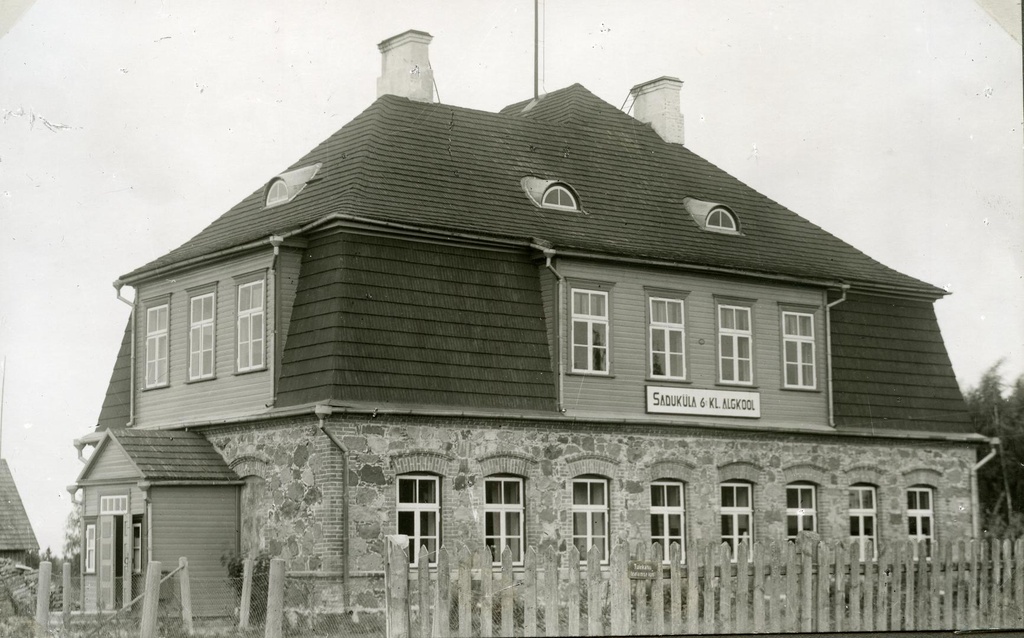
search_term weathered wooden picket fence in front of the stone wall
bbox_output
[386,539,1024,638]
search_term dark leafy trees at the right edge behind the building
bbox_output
[964,360,1024,538]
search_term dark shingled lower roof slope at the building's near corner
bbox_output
[278,235,556,411]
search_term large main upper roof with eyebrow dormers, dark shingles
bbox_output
[119,84,943,297]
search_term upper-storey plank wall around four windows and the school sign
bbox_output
[558,260,828,426]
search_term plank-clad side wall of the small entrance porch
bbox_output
[151,485,239,615]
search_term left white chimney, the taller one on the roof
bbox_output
[377,31,434,102]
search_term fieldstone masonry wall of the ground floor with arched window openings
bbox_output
[206,414,976,609]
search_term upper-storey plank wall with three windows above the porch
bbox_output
[135,248,295,427]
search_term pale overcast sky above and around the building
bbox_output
[0,0,1024,550]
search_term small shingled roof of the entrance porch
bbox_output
[108,428,239,482]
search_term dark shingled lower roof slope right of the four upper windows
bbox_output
[831,293,974,432]
